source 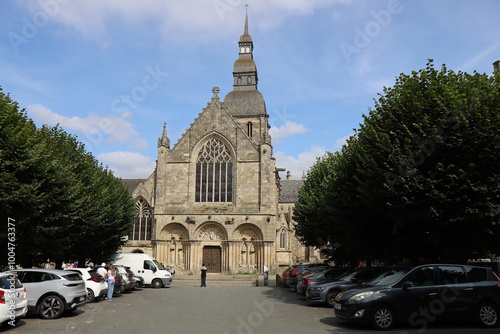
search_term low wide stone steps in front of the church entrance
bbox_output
[172,274,276,287]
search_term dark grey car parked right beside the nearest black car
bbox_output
[306,267,388,307]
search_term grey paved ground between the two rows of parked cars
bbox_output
[0,281,498,334]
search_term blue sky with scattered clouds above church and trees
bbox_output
[0,0,500,179]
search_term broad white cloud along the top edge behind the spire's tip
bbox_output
[18,0,349,42]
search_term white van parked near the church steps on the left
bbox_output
[113,253,172,288]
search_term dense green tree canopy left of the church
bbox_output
[0,89,134,266]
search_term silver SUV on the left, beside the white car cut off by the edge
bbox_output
[9,268,87,319]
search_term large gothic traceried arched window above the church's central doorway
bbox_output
[195,138,233,202]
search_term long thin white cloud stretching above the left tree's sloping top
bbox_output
[27,104,147,149]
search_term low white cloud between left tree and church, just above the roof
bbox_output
[97,151,155,179]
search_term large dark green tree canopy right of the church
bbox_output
[294,61,500,263]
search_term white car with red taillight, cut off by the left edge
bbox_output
[0,273,28,325]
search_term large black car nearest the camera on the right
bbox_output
[334,264,500,330]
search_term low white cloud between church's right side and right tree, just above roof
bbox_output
[275,146,325,180]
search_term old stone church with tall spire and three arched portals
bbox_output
[121,13,319,274]
